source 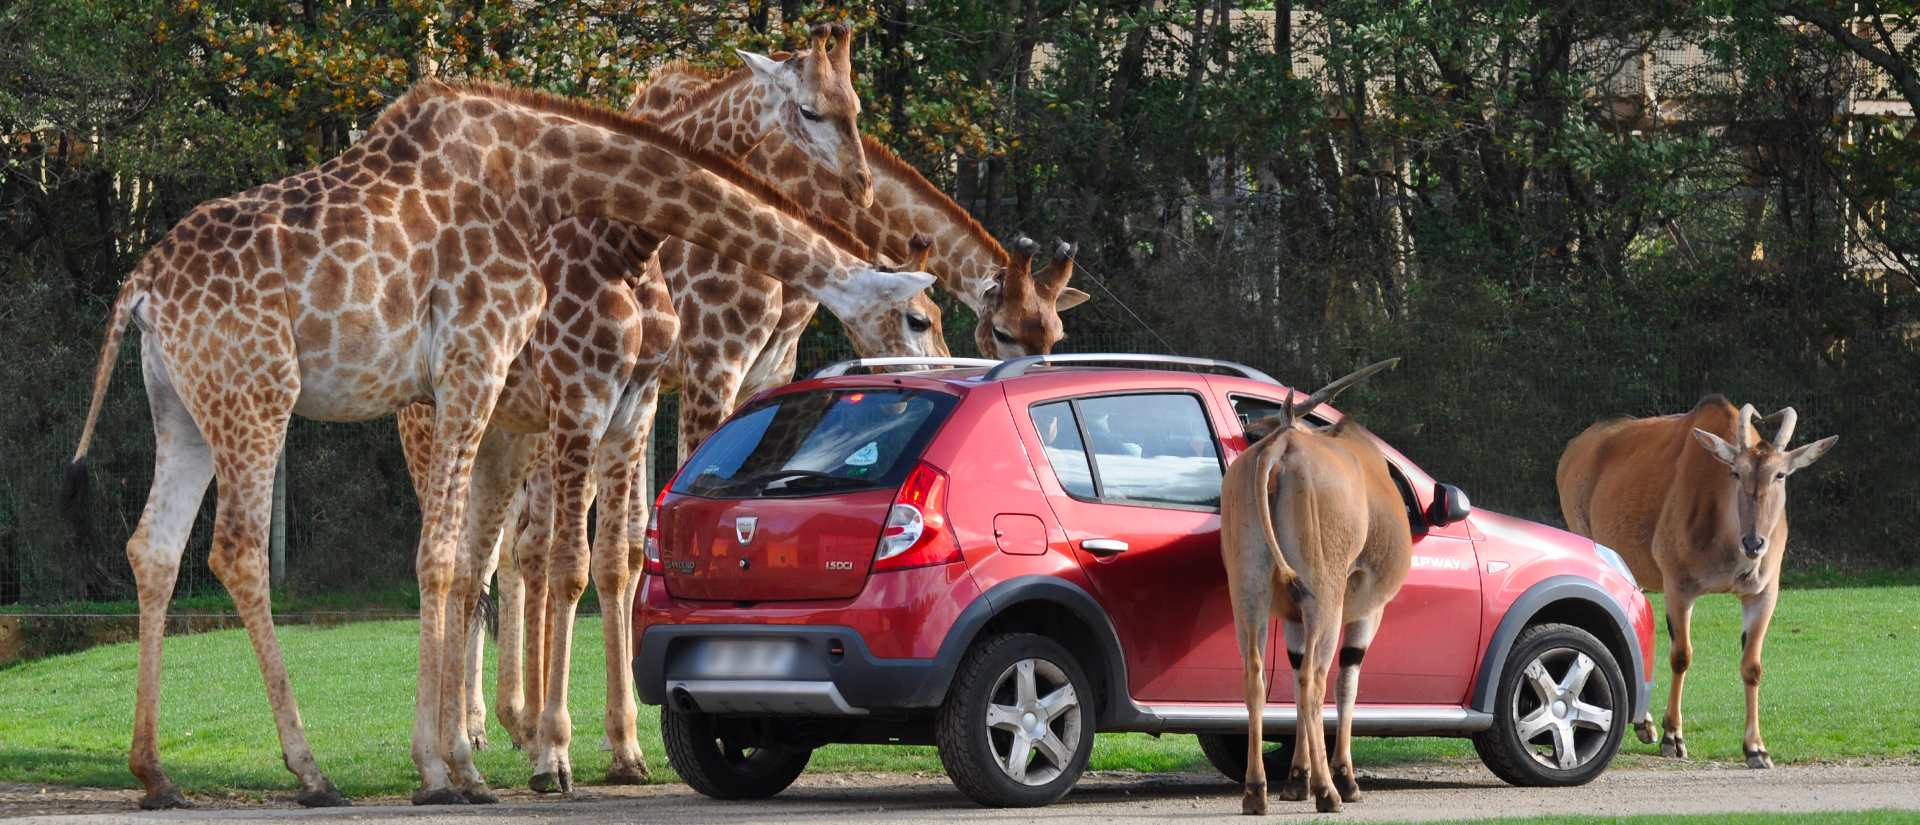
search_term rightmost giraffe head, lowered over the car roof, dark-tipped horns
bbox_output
[973,236,1087,359]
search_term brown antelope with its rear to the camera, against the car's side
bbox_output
[1219,359,1413,813]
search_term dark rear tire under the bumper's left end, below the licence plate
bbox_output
[660,706,814,800]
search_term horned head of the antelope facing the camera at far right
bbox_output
[1693,405,1839,558]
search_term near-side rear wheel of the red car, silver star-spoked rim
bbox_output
[935,633,1094,808]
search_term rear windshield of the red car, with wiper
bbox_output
[674,388,956,499]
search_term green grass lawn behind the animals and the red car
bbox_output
[0,587,1920,794]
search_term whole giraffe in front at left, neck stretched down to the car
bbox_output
[61,81,933,808]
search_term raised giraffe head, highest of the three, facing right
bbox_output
[739,23,874,209]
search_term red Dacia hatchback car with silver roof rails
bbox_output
[634,355,1653,806]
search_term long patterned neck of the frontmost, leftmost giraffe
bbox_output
[405,86,870,315]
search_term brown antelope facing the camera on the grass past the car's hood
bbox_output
[1557,395,1839,767]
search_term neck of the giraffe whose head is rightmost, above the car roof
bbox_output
[745,134,1008,313]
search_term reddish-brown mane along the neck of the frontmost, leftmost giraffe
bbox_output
[403,81,874,261]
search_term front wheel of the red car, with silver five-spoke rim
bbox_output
[1473,624,1634,789]
